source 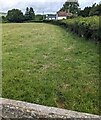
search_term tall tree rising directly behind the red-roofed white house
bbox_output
[60,0,79,14]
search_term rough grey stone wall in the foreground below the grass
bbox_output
[0,98,101,120]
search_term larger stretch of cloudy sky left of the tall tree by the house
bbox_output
[0,0,66,12]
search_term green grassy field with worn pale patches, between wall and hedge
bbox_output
[2,23,99,114]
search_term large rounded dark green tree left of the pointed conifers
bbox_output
[7,9,24,22]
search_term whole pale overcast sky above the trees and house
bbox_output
[0,0,101,13]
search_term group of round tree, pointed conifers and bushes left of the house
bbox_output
[2,7,43,23]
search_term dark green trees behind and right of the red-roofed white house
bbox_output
[59,0,101,17]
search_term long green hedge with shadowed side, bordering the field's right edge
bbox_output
[44,16,101,41]
